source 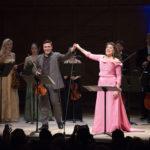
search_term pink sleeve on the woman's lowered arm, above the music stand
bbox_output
[115,61,122,86]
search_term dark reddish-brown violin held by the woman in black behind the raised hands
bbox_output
[70,82,81,101]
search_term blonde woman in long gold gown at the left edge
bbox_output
[0,39,19,122]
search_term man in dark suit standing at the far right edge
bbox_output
[136,33,150,123]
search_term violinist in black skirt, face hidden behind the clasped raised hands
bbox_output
[63,56,82,121]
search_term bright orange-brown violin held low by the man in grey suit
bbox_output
[32,61,47,96]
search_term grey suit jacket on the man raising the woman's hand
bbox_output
[32,50,72,89]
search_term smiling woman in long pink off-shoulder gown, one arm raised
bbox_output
[74,42,131,133]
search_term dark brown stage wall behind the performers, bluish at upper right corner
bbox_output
[0,0,150,112]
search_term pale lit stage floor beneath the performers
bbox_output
[0,115,150,142]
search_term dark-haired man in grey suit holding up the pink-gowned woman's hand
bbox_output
[33,40,75,129]
